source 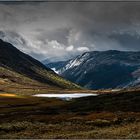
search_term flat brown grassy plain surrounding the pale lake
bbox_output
[0,86,140,139]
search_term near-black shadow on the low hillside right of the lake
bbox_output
[66,91,140,112]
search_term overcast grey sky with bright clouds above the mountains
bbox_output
[0,2,140,61]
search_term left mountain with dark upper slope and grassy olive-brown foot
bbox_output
[0,40,80,89]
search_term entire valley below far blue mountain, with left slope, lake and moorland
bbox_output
[0,40,140,139]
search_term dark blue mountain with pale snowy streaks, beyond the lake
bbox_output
[47,50,140,89]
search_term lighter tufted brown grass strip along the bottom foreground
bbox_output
[0,121,140,139]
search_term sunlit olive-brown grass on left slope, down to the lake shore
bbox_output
[0,67,81,95]
